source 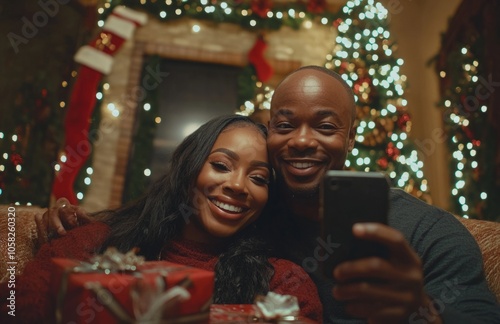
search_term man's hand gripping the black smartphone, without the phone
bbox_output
[333,223,442,323]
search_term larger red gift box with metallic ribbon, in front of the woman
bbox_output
[51,258,214,323]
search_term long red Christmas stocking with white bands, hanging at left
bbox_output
[52,6,147,205]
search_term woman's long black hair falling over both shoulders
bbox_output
[96,115,274,304]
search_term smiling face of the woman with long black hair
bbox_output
[184,125,270,242]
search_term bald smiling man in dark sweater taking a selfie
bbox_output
[268,66,500,323]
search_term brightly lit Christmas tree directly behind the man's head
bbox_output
[325,0,430,201]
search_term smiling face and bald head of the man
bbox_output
[267,69,355,195]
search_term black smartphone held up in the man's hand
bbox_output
[320,170,390,277]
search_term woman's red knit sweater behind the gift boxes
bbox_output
[0,222,322,323]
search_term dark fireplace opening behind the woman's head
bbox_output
[122,58,242,203]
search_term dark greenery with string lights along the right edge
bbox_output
[439,29,500,221]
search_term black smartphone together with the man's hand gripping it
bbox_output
[320,171,441,323]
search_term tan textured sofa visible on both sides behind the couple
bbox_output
[0,205,500,302]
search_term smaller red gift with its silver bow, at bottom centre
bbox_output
[210,292,315,324]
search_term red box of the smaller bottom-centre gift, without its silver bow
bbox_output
[210,304,316,324]
